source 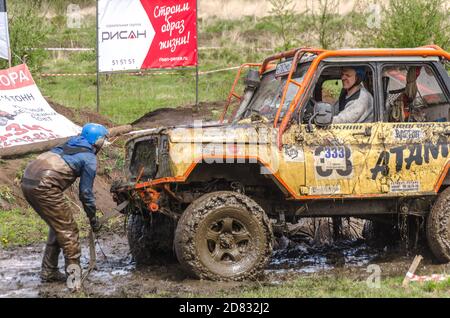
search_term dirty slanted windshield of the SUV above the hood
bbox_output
[243,63,310,120]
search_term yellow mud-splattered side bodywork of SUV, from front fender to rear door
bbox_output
[161,122,450,199]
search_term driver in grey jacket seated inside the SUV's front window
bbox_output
[333,66,373,124]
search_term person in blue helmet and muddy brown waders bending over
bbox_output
[21,123,108,282]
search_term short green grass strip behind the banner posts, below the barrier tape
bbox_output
[38,72,235,124]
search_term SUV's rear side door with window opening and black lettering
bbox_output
[372,61,450,196]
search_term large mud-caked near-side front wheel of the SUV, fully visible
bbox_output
[175,191,273,281]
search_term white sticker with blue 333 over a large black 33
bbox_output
[314,146,353,179]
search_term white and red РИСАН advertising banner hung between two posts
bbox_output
[97,0,197,72]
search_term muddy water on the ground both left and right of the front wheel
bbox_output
[0,235,449,297]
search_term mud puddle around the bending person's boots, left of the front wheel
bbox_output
[0,235,240,298]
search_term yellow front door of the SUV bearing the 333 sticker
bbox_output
[301,64,383,198]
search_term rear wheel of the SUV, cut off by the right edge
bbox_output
[426,188,450,263]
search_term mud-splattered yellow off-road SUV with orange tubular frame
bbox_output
[112,46,450,280]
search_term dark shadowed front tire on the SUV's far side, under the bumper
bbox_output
[127,213,175,264]
